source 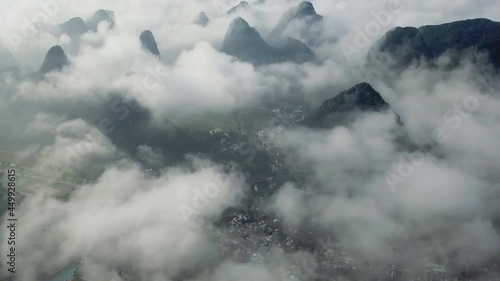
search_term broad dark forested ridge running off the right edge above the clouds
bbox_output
[368,19,500,68]
